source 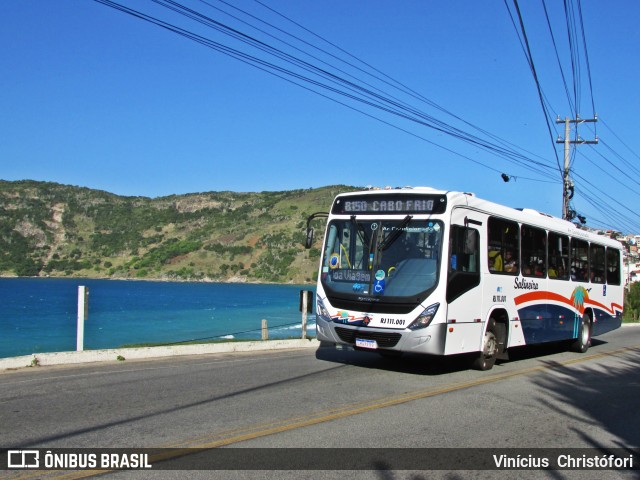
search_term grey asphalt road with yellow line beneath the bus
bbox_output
[0,326,640,480]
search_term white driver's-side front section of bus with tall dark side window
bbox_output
[445,208,484,355]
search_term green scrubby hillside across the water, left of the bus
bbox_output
[0,181,354,283]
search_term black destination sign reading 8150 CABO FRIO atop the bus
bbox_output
[331,194,447,215]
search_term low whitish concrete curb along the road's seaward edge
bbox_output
[0,339,320,371]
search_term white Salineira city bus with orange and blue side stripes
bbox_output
[307,187,623,370]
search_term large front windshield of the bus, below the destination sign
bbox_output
[321,215,444,303]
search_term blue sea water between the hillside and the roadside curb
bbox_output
[0,278,315,358]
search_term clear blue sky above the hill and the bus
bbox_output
[0,0,640,233]
